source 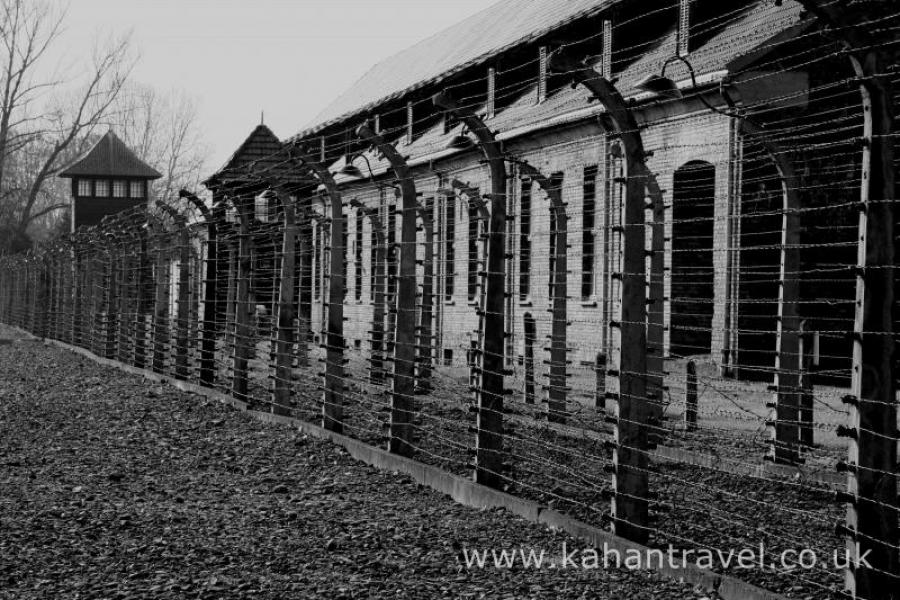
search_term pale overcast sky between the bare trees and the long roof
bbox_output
[61,0,495,170]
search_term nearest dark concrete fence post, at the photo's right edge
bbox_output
[838,47,900,600]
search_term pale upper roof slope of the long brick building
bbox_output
[298,0,612,137]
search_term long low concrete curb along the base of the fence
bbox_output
[14,331,787,600]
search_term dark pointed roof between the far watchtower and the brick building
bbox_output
[204,124,304,184]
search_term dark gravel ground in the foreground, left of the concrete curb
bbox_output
[0,338,708,599]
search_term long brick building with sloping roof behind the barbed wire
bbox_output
[214,0,858,376]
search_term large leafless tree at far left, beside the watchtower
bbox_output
[0,0,134,252]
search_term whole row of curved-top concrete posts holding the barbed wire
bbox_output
[0,11,900,600]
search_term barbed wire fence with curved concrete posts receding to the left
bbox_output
[0,3,900,600]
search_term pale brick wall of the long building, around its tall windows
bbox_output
[302,106,736,392]
